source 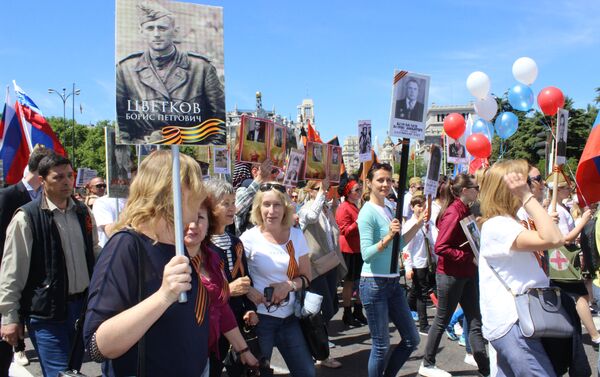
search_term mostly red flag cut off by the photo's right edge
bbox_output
[576,113,600,204]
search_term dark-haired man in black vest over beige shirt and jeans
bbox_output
[0,154,100,376]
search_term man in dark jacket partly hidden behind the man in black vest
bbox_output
[0,147,53,377]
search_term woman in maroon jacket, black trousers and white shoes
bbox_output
[419,174,490,377]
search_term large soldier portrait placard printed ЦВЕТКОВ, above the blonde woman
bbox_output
[115,0,226,145]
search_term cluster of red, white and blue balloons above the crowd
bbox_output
[444,57,565,159]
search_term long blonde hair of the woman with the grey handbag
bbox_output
[479,160,529,223]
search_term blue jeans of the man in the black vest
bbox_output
[27,299,83,377]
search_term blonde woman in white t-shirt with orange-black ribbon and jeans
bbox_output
[240,183,315,377]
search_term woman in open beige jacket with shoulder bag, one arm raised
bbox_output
[298,179,346,368]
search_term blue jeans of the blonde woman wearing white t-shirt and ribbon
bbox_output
[256,314,315,377]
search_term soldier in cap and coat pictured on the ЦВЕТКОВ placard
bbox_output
[116,1,225,144]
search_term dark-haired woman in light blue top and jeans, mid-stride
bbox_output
[357,163,426,377]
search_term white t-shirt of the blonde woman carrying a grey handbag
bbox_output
[479,216,550,341]
